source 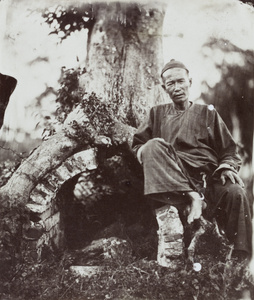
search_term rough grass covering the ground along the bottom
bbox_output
[0,239,253,300]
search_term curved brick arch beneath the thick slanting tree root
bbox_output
[23,148,97,260]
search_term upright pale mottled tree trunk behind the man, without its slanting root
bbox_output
[81,3,167,127]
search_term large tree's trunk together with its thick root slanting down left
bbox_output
[0,3,168,207]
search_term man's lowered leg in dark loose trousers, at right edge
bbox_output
[207,180,252,254]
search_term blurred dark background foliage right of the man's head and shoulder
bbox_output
[201,39,254,162]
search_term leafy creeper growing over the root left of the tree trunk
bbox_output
[43,68,116,144]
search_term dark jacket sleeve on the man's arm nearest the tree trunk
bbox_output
[132,108,154,156]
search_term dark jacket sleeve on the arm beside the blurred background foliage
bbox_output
[210,111,241,174]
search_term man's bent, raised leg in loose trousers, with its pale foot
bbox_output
[142,139,204,223]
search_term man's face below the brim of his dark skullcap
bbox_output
[163,68,191,104]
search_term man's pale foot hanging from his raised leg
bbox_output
[187,191,206,224]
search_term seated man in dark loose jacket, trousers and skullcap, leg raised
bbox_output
[133,60,252,255]
